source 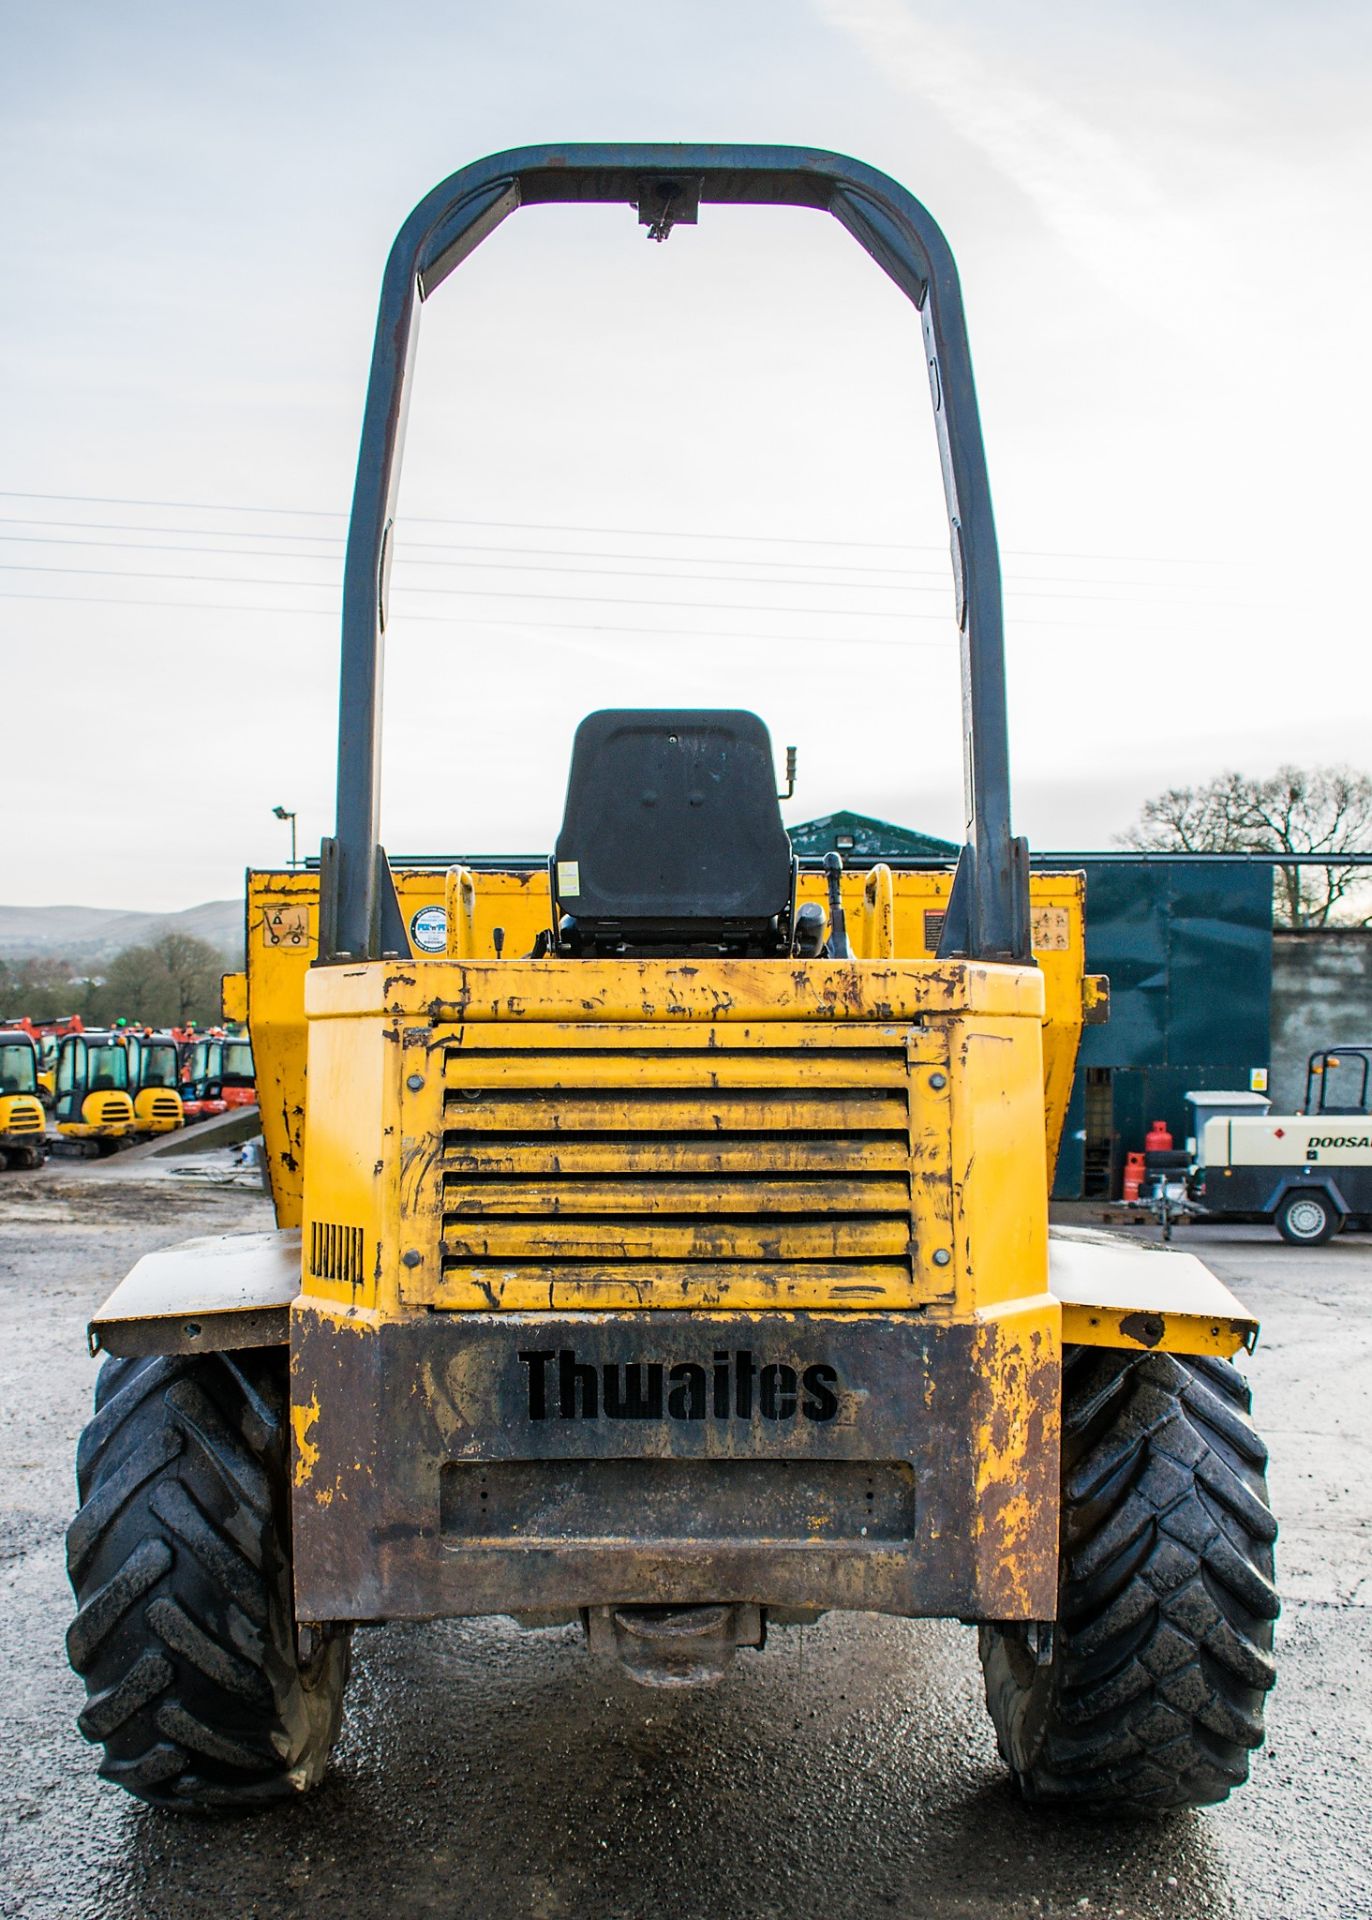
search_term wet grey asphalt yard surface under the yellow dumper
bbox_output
[0,1162,1372,1920]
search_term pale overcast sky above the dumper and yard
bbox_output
[0,0,1372,908]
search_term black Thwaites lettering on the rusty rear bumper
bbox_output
[516,1346,842,1421]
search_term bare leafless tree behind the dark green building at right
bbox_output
[1119,766,1372,927]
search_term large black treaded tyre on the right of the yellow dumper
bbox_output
[981,1348,1280,1812]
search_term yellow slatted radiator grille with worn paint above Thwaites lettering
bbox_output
[441,1043,932,1306]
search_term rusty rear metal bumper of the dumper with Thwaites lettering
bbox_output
[292,1298,1061,1620]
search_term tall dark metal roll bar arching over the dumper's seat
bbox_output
[319,144,1030,962]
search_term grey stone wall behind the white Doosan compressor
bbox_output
[1268,927,1372,1114]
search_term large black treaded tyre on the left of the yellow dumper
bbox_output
[67,1348,349,1809]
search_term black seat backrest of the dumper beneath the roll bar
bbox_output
[553,708,792,947]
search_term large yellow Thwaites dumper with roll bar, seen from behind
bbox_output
[69,146,1278,1809]
